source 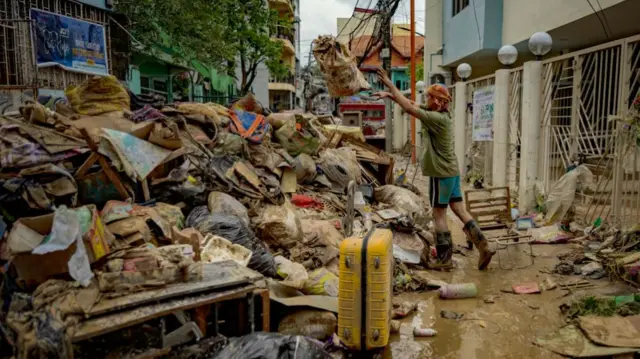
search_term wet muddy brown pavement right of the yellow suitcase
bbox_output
[383,214,630,359]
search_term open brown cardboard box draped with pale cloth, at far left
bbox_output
[7,205,112,283]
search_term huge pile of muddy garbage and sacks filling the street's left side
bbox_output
[0,77,431,358]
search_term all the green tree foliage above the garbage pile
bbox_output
[117,0,292,93]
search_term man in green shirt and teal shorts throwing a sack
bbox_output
[376,70,495,270]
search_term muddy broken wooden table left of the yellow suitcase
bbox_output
[72,261,270,349]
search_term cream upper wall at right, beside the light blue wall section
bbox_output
[502,0,624,45]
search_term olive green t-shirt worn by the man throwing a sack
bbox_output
[418,109,460,177]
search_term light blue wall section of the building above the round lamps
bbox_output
[442,0,502,64]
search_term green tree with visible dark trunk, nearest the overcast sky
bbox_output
[217,0,292,94]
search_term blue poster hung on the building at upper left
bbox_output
[31,9,109,75]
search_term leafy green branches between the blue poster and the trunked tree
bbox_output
[116,0,234,70]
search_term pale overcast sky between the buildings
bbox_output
[300,0,425,66]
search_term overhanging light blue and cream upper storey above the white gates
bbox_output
[424,0,640,80]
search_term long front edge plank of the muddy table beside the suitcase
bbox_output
[71,284,256,342]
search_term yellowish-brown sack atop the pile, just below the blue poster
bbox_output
[64,76,130,116]
